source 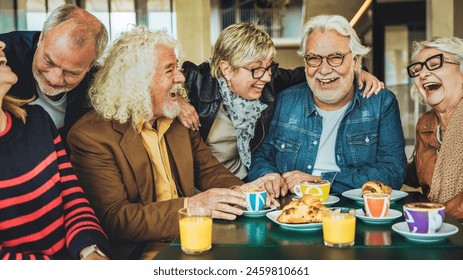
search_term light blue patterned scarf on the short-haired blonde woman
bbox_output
[217,78,267,169]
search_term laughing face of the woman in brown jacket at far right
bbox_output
[413,48,463,111]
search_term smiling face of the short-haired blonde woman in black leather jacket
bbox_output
[220,57,273,100]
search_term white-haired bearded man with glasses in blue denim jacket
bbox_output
[248,15,406,193]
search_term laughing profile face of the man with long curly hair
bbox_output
[150,45,185,123]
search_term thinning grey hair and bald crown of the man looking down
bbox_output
[42,4,108,62]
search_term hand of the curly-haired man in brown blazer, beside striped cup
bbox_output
[187,188,246,220]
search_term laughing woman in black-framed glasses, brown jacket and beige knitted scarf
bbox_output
[405,37,463,221]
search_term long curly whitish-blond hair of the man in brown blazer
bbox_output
[89,26,180,125]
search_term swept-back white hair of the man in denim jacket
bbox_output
[297,15,370,72]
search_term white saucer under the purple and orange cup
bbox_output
[392,222,458,243]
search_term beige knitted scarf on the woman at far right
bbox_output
[430,100,463,203]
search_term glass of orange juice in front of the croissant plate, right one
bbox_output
[322,207,356,248]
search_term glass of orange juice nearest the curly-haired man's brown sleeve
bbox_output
[178,207,212,254]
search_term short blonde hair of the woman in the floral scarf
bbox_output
[211,22,276,78]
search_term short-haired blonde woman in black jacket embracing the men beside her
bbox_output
[180,23,384,197]
